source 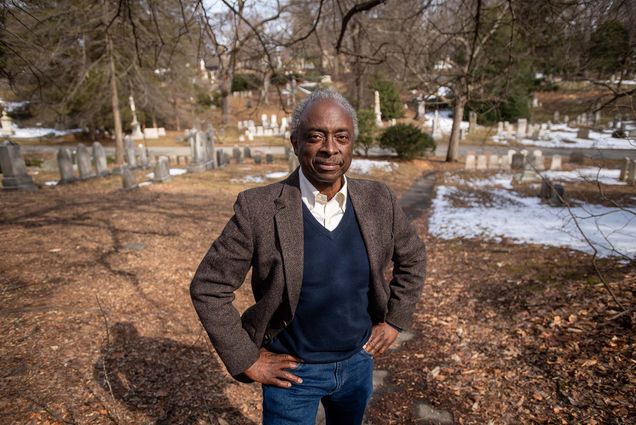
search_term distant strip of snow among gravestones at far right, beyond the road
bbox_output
[492,124,636,149]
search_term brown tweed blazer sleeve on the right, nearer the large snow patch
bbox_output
[385,188,426,329]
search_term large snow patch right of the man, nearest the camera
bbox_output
[429,178,636,258]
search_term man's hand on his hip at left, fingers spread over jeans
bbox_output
[244,348,303,388]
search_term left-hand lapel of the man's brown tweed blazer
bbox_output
[275,169,304,315]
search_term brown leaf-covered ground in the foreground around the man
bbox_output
[0,157,636,424]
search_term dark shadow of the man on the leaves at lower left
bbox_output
[94,322,254,425]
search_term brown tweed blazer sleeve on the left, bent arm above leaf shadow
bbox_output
[190,193,259,377]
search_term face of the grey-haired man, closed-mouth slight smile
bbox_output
[292,100,354,196]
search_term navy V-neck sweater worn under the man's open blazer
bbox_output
[269,200,371,363]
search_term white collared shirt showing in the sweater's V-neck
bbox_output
[298,169,347,231]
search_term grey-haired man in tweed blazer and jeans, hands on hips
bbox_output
[191,90,425,425]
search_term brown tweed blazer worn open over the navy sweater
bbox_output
[190,170,426,381]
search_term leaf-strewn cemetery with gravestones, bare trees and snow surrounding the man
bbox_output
[0,1,636,425]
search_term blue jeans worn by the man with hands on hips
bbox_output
[263,350,373,425]
